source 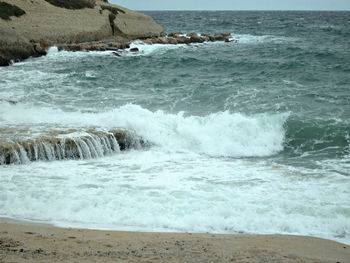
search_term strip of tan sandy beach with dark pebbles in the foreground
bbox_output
[0,222,350,263]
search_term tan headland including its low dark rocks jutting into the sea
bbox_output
[0,0,236,66]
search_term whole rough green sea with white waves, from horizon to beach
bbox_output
[0,11,350,244]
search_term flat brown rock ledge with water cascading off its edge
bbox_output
[0,128,147,165]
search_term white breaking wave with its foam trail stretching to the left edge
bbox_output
[0,105,288,157]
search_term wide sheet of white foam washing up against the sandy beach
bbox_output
[0,151,350,243]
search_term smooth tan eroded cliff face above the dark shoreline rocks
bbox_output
[0,0,163,66]
